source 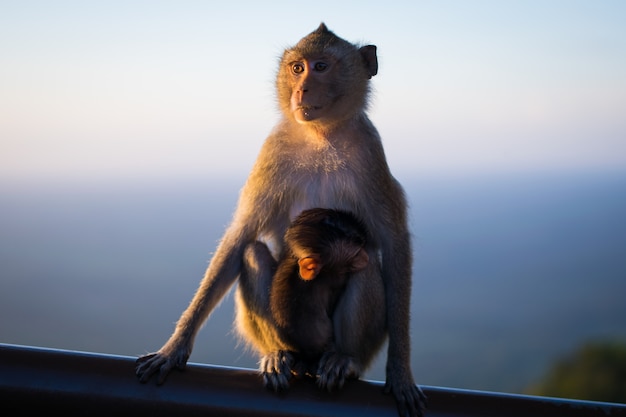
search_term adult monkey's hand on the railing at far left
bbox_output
[135,343,191,385]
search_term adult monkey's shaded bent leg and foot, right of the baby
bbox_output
[317,256,386,391]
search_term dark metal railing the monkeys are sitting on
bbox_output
[0,344,626,417]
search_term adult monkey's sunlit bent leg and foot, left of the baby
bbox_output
[237,242,296,391]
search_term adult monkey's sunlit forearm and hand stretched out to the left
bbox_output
[136,223,249,384]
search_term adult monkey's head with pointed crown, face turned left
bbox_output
[276,23,378,128]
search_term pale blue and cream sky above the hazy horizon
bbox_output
[0,0,626,181]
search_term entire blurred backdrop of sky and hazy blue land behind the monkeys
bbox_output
[0,0,626,402]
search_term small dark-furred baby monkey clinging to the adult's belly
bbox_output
[270,208,369,364]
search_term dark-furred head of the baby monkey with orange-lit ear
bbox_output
[285,208,369,281]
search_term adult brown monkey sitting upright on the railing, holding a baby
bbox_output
[136,23,425,416]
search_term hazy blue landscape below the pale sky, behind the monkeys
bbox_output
[0,175,626,400]
